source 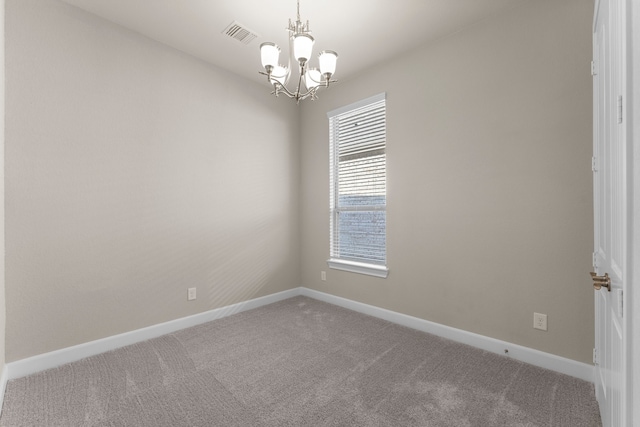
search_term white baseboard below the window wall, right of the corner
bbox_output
[300,288,594,383]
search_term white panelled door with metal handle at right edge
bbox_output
[593,0,627,427]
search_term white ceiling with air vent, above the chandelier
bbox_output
[63,0,526,85]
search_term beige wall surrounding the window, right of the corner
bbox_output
[301,0,594,363]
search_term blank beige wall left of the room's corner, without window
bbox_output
[5,0,300,362]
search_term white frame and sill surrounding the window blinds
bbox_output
[327,92,389,278]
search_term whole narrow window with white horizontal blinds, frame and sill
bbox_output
[327,93,389,277]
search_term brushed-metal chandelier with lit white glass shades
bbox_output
[259,0,338,102]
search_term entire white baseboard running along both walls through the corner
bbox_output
[0,287,594,390]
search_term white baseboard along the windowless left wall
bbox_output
[5,288,300,382]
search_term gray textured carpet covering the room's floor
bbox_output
[0,297,601,427]
